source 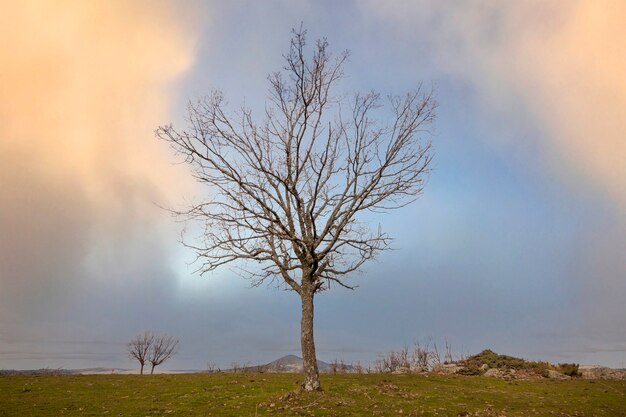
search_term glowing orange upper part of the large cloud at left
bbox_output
[0,0,194,206]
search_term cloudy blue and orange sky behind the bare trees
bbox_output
[0,0,626,369]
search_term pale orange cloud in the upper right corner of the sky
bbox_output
[516,1,626,214]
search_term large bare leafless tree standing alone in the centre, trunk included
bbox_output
[156,29,436,390]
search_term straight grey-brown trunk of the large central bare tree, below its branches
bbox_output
[300,292,321,391]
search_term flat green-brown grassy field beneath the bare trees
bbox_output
[0,373,626,417]
